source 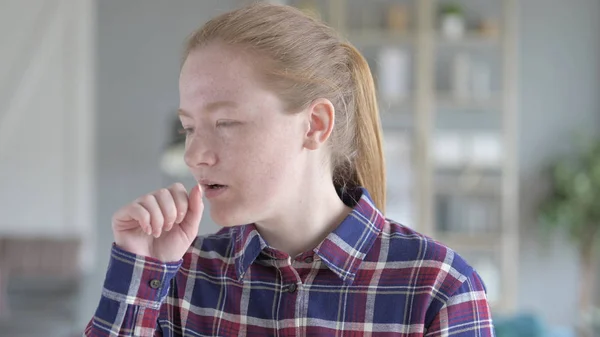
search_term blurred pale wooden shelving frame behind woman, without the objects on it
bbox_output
[270,0,519,313]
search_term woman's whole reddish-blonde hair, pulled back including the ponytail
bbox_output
[184,2,386,212]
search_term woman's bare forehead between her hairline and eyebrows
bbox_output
[179,45,258,101]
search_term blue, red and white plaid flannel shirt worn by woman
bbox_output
[84,189,494,337]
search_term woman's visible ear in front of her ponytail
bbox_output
[304,98,335,150]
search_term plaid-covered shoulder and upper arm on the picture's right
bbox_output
[380,219,491,330]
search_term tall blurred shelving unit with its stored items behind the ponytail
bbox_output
[284,0,519,312]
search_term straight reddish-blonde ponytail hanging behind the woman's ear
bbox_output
[342,43,386,213]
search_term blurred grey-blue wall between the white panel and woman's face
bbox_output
[80,0,237,324]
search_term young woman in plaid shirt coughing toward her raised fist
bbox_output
[85,4,493,336]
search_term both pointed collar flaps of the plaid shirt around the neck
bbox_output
[233,188,385,284]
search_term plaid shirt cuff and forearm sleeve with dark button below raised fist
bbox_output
[84,244,182,337]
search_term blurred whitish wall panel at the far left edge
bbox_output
[0,0,96,266]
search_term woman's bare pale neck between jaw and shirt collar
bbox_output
[256,176,351,258]
